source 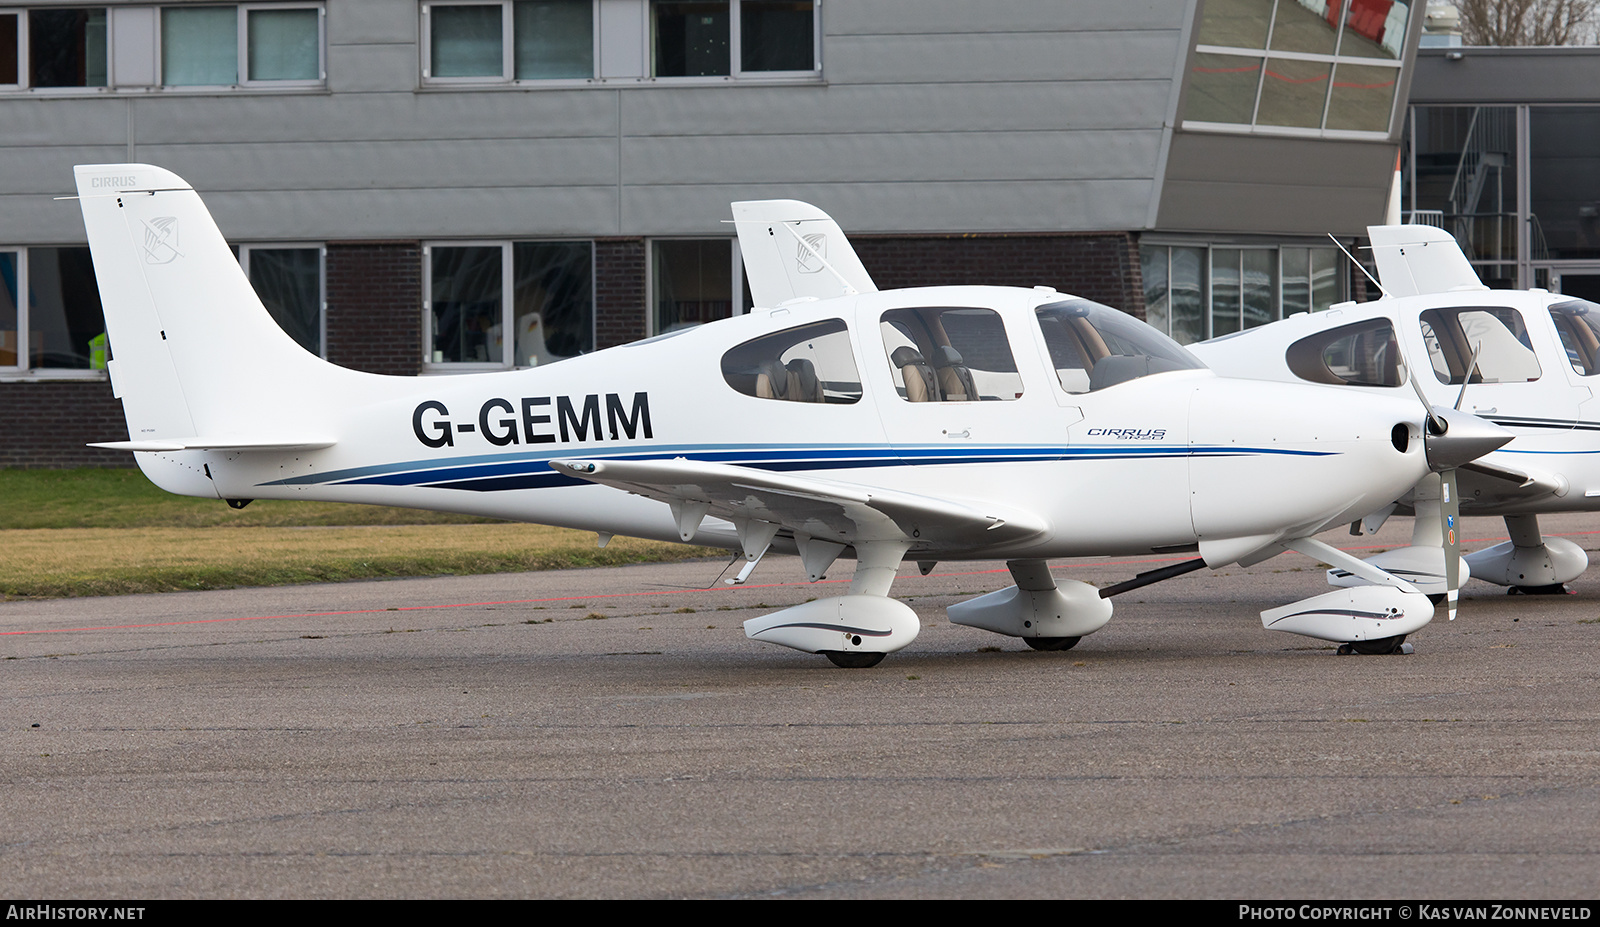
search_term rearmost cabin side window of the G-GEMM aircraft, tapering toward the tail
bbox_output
[722,319,861,403]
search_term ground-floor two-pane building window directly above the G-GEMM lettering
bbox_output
[422,242,594,371]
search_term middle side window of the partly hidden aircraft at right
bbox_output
[1421,306,1541,384]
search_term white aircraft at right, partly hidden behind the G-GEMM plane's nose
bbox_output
[1192,226,1600,594]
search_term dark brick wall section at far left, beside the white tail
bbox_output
[0,379,133,468]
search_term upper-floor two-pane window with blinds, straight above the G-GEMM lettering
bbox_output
[422,0,595,82]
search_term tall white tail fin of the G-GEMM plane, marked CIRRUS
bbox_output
[75,165,368,447]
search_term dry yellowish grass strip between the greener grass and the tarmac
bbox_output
[0,524,725,599]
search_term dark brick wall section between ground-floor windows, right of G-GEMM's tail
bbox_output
[326,242,422,376]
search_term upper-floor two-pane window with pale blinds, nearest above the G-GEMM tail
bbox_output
[162,3,325,86]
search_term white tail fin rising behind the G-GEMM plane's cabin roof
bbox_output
[733,200,877,307]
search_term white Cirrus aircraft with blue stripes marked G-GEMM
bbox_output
[68,165,1509,666]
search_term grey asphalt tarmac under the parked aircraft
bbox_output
[0,516,1600,900]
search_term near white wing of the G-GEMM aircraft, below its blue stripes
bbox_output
[550,458,1048,549]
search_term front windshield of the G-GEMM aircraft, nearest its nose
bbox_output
[1034,299,1205,392]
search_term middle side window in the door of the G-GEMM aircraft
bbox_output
[878,307,1022,402]
